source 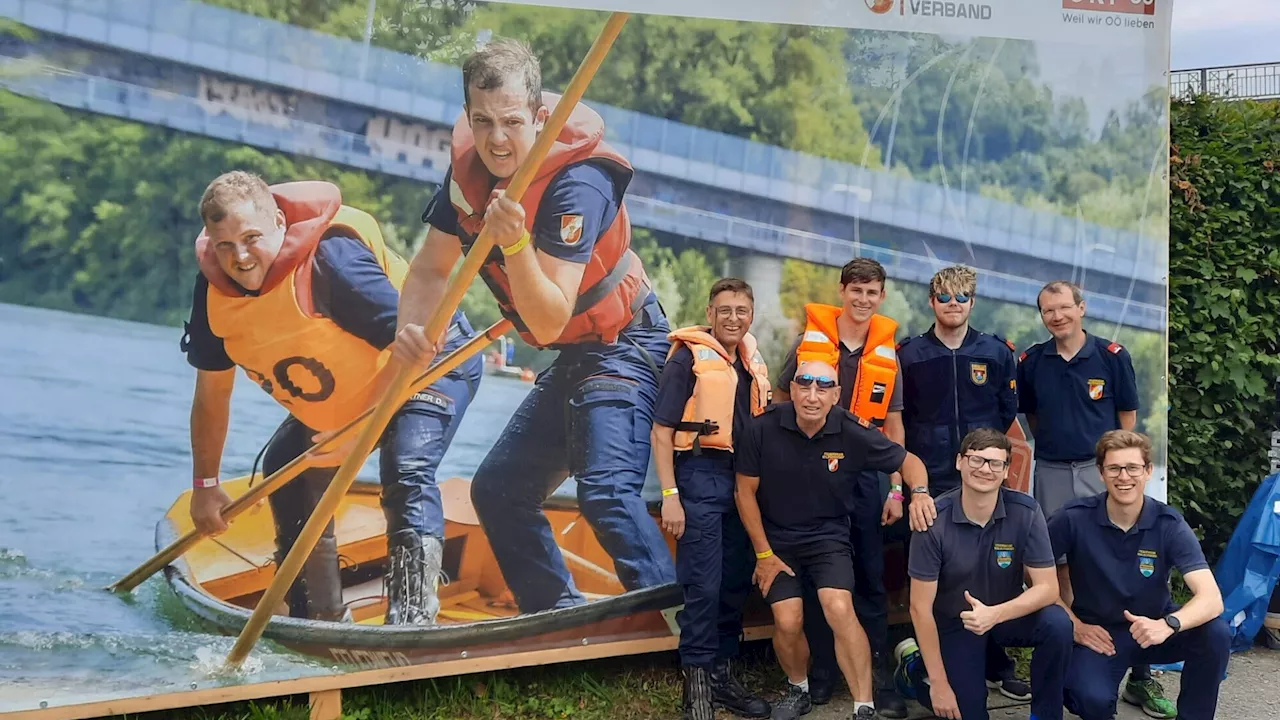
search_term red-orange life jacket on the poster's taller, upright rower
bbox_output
[449,92,652,347]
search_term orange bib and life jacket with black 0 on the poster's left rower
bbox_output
[196,182,408,432]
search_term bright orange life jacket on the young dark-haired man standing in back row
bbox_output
[796,302,897,427]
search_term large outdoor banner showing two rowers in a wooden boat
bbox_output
[0,0,1171,712]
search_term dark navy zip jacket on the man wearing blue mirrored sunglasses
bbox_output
[897,327,1018,491]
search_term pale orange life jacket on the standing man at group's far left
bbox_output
[667,325,771,454]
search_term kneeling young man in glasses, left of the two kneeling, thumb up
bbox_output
[909,428,1071,720]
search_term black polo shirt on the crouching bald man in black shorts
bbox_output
[736,402,906,547]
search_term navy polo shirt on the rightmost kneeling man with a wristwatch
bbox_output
[1048,492,1208,625]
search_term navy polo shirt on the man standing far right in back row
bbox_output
[1018,334,1138,462]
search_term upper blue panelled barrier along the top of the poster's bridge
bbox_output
[0,0,1167,284]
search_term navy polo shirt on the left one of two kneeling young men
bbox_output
[908,488,1053,632]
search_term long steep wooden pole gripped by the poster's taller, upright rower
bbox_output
[227,13,628,670]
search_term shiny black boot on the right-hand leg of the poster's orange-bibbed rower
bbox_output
[384,529,444,625]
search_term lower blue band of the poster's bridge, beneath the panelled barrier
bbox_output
[0,56,1165,331]
